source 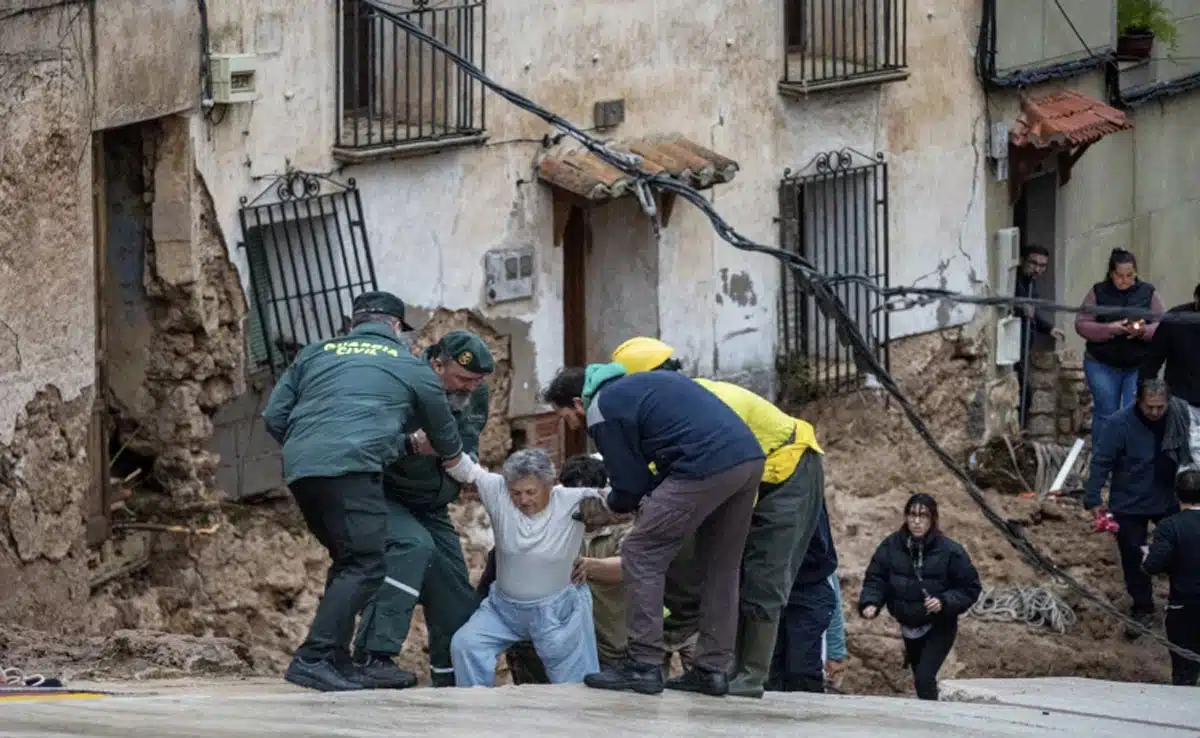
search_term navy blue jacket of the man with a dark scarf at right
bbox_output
[1084,406,1178,516]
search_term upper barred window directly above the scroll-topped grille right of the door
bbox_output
[780,0,908,94]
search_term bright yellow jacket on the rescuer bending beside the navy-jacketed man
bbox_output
[696,379,824,485]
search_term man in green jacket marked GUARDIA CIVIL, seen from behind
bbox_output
[263,292,480,691]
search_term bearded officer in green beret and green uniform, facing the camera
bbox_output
[354,330,494,689]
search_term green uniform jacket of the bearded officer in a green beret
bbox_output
[383,383,487,510]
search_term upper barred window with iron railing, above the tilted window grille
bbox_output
[335,0,487,158]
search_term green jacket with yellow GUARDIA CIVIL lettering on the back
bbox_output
[263,323,462,484]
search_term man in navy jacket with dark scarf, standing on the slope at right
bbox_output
[1084,379,1181,637]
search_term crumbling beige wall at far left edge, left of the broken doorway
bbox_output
[0,6,95,624]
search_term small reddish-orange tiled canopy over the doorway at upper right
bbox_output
[1010,90,1133,149]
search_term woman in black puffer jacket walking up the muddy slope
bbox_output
[858,493,983,700]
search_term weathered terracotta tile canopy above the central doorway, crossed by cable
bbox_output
[538,136,738,200]
